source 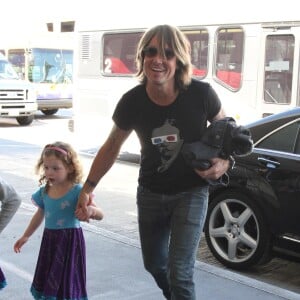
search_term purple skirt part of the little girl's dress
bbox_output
[31,228,88,300]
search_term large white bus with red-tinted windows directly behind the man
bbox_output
[70,1,300,152]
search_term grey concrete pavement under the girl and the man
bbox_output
[0,203,300,300]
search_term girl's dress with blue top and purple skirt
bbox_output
[31,184,88,300]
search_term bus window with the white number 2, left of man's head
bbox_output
[103,32,142,75]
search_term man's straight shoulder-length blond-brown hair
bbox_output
[136,25,193,90]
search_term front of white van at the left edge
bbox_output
[0,53,37,125]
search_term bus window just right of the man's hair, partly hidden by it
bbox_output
[184,29,208,78]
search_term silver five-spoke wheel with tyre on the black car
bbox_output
[205,191,271,270]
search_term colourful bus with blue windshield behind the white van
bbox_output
[0,32,74,115]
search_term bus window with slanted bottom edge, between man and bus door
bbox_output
[215,28,244,90]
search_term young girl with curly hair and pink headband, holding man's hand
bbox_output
[14,142,103,300]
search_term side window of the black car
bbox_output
[256,121,300,154]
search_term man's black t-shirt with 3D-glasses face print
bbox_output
[113,80,221,194]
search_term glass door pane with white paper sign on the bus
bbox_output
[264,35,295,104]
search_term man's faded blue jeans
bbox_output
[137,186,208,300]
